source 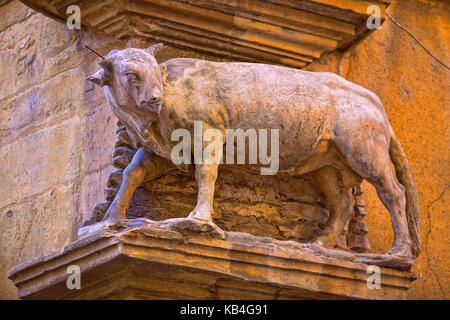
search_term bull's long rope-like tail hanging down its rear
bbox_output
[389,129,421,258]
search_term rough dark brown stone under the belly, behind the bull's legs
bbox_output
[134,167,328,241]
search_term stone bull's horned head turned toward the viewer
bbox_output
[87,43,163,118]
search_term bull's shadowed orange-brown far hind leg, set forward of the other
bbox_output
[313,166,358,248]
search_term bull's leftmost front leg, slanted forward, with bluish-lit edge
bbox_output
[103,148,154,221]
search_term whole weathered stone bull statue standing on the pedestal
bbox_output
[88,44,420,258]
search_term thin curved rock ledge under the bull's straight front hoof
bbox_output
[159,216,226,239]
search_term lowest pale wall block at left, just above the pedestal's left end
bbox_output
[0,182,80,299]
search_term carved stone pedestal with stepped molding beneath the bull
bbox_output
[8,219,415,299]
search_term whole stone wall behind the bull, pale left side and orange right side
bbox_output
[0,0,450,299]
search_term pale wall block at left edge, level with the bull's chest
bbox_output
[0,118,80,206]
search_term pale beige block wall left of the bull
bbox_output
[0,1,116,298]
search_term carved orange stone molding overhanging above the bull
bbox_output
[22,0,389,68]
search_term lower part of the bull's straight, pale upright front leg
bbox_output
[189,163,219,222]
